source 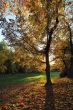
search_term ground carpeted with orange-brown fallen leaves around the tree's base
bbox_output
[0,78,73,110]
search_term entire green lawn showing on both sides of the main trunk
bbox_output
[0,72,59,87]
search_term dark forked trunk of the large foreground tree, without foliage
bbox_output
[45,0,59,85]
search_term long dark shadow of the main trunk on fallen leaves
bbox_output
[44,80,56,110]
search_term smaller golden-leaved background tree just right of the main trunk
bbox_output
[52,37,71,77]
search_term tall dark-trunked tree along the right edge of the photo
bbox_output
[48,1,73,77]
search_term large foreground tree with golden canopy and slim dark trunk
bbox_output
[0,0,62,84]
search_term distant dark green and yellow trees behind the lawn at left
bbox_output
[0,41,41,74]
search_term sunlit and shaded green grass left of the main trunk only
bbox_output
[0,74,45,88]
